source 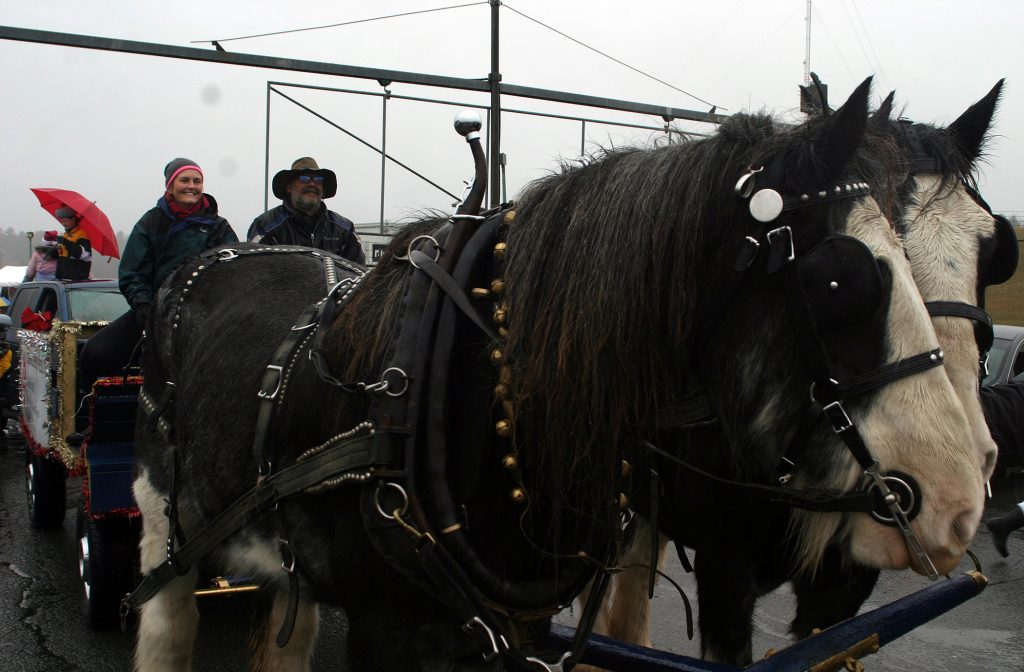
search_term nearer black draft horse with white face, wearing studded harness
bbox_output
[128,80,982,671]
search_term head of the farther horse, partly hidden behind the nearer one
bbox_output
[869,80,1018,487]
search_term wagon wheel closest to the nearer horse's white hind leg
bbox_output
[75,505,139,628]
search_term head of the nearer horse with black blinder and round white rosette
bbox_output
[663,78,983,574]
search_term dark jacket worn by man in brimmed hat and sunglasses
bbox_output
[246,203,367,263]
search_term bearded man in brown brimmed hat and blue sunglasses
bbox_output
[247,157,366,263]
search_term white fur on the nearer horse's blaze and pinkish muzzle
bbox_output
[795,199,983,574]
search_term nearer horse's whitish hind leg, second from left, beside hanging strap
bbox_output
[253,590,319,672]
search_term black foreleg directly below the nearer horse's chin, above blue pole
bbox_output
[790,545,879,639]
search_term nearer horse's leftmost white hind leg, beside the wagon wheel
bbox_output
[134,471,199,672]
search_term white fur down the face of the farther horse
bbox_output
[903,175,997,480]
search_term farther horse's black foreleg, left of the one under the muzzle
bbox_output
[693,549,758,667]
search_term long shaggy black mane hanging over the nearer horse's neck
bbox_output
[504,114,868,528]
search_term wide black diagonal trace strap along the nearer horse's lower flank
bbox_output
[122,428,387,613]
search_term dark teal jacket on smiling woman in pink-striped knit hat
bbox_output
[118,194,239,309]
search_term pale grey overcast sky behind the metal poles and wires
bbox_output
[0,0,1024,257]
